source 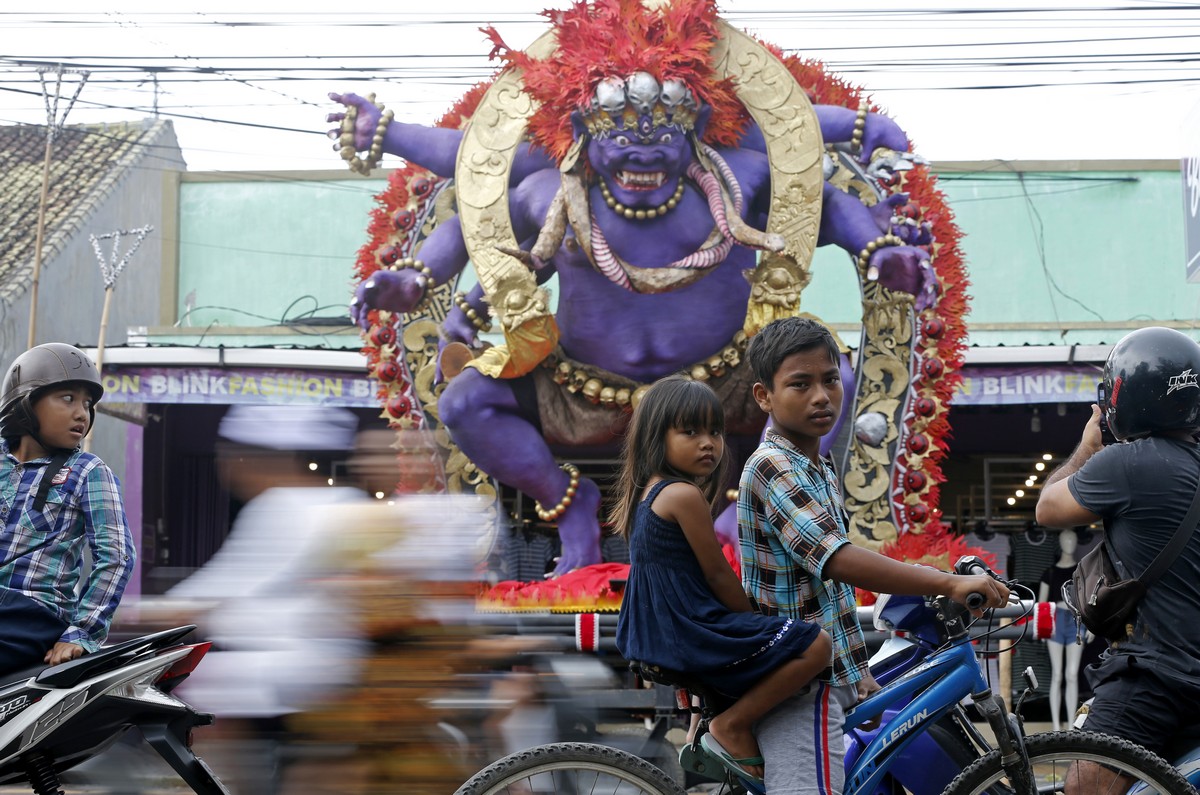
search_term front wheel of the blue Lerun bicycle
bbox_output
[942,731,1195,795]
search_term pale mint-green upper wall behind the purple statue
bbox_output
[178,163,1200,348]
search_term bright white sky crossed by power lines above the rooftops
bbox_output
[0,0,1200,168]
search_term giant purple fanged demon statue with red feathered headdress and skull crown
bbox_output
[329,0,956,573]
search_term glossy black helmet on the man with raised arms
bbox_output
[1098,327,1200,442]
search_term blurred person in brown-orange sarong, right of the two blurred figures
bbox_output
[286,430,492,795]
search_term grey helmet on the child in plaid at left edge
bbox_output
[0,342,104,447]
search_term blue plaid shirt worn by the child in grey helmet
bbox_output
[0,442,134,651]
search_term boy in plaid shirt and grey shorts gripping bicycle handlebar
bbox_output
[738,317,1008,795]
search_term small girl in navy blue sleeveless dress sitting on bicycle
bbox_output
[610,376,833,777]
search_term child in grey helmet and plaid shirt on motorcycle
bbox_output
[0,342,134,674]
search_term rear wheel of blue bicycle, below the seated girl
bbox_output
[455,742,684,795]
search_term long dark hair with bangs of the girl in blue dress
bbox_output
[608,376,727,539]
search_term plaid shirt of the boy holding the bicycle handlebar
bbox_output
[738,431,868,686]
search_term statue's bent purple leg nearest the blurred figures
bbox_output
[438,367,600,574]
